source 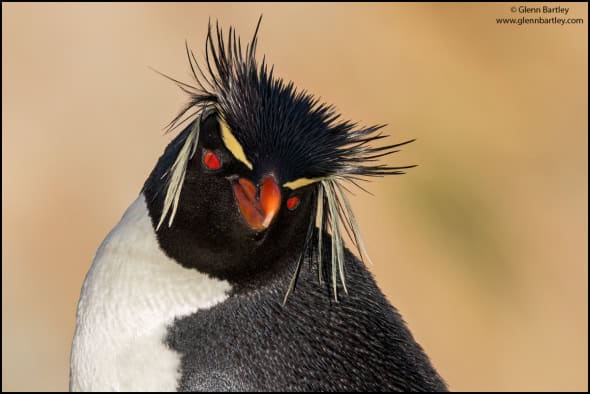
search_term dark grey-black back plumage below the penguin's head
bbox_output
[167,245,446,391]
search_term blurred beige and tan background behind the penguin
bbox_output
[2,3,588,390]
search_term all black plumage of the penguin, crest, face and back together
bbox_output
[143,17,446,391]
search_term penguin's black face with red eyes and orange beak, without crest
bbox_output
[144,113,314,285]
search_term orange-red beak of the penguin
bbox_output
[233,176,281,231]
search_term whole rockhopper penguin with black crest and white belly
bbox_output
[70,21,447,391]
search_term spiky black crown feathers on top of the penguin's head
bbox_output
[166,20,413,182]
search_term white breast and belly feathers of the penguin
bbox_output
[70,194,231,391]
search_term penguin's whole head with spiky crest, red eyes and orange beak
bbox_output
[143,21,412,296]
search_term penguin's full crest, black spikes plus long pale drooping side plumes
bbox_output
[157,19,414,301]
